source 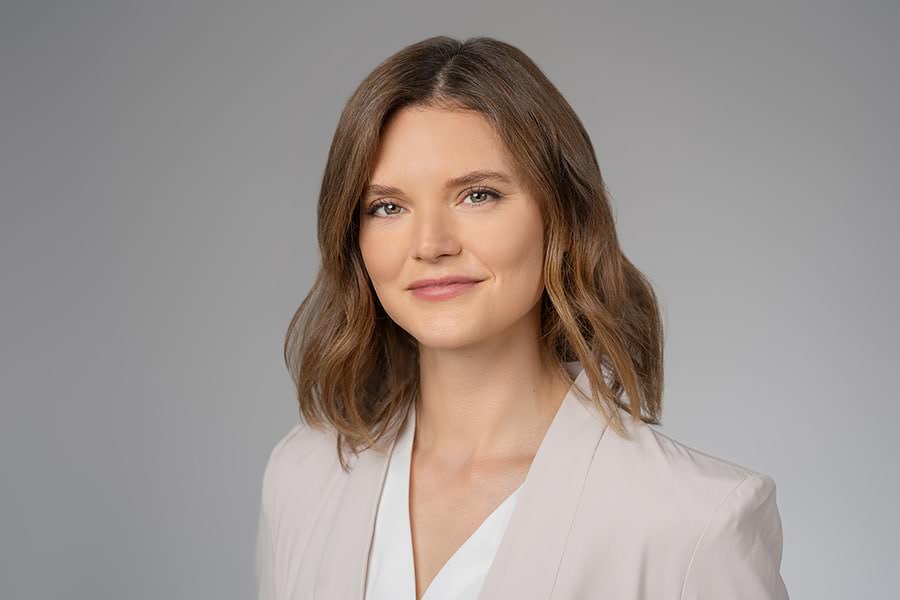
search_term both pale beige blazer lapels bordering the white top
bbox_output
[314,361,606,600]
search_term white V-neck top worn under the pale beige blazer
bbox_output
[365,410,525,600]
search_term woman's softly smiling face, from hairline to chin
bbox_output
[359,107,543,348]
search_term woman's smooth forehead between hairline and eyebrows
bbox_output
[370,107,512,185]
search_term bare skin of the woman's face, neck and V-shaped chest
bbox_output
[359,107,569,597]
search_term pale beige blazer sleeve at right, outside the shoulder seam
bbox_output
[681,473,789,600]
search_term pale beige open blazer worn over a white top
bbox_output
[255,362,788,600]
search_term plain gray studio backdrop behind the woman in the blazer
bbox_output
[0,0,900,600]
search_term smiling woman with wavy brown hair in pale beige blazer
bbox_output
[257,36,788,600]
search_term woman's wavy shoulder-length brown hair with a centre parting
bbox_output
[284,36,663,471]
